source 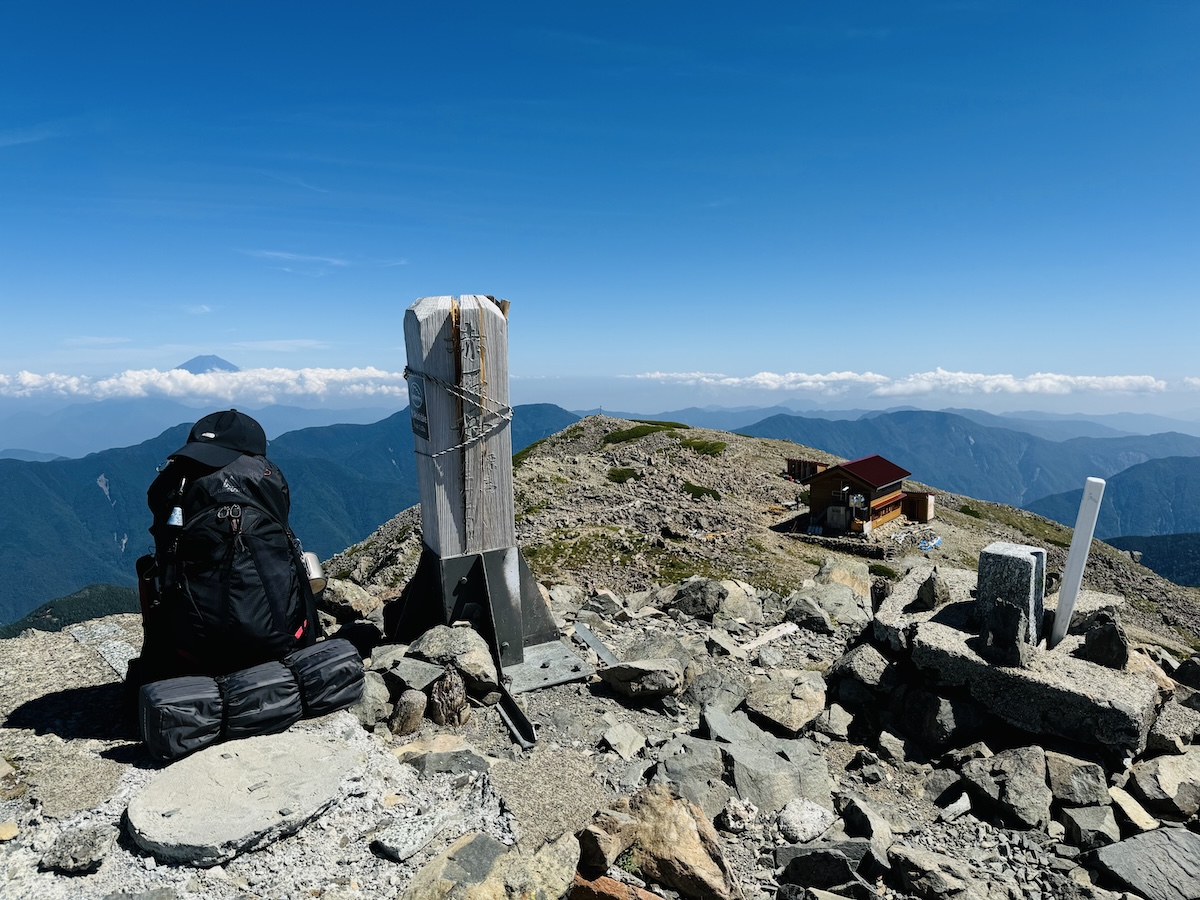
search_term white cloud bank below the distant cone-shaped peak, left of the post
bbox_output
[0,366,408,403]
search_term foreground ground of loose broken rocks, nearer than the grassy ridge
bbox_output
[0,540,1200,900]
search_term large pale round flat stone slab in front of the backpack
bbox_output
[126,732,364,866]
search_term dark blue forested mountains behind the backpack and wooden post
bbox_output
[0,404,578,623]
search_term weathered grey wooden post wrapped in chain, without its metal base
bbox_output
[404,300,516,559]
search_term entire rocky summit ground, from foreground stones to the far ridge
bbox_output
[0,416,1200,900]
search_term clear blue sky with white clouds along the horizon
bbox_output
[0,1,1200,418]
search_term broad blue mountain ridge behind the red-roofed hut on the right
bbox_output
[740,410,1200,508]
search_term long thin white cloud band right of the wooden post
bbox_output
[637,368,1171,397]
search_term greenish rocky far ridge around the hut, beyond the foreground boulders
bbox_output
[326,415,1200,646]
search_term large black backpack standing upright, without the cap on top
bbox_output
[128,454,320,685]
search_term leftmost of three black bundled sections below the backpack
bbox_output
[138,676,224,760]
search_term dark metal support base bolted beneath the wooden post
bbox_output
[384,547,595,746]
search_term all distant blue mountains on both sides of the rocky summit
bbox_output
[7,398,1200,623]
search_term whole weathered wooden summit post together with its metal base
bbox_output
[385,294,592,724]
